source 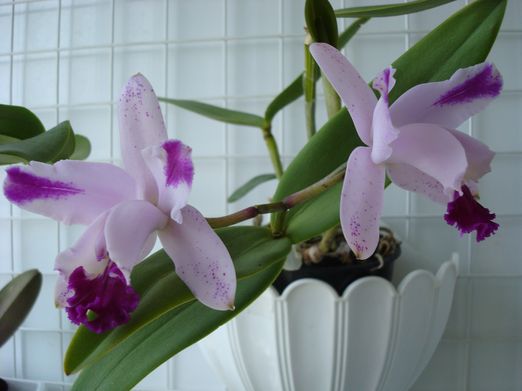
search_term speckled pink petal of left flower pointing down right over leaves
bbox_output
[159,205,236,310]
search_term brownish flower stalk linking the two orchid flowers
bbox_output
[207,163,346,230]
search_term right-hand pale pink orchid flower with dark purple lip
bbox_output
[310,43,502,259]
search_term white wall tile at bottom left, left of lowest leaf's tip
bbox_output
[21,331,62,381]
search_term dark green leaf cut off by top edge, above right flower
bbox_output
[305,0,339,47]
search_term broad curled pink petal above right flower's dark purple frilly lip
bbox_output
[387,124,468,195]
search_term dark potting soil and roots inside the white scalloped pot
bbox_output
[273,228,401,296]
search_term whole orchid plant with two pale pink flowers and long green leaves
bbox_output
[0,0,506,389]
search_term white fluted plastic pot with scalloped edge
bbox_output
[200,261,458,391]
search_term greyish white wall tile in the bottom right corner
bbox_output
[468,341,522,391]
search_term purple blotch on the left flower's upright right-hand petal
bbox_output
[163,140,194,186]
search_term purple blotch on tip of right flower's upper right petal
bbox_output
[433,64,502,106]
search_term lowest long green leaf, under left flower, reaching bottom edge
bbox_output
[73,258,285,391]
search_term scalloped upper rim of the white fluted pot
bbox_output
[270,255,458,300]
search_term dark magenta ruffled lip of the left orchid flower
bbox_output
[65,262,139,333]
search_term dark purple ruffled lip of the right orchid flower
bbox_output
[444,185,499,242]
